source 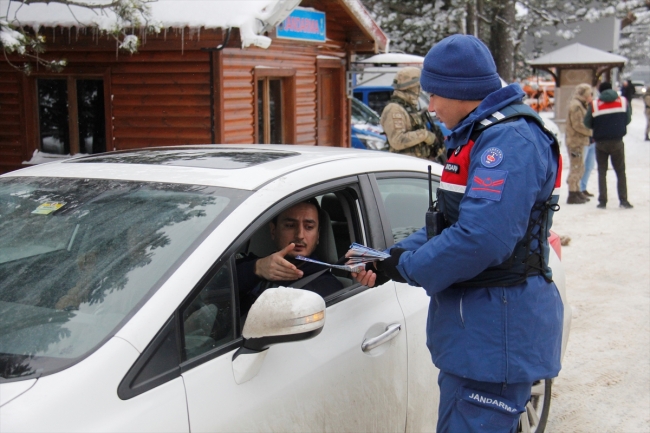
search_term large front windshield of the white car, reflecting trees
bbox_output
[0,177,250,379]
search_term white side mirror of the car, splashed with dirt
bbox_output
[232,287,325,384]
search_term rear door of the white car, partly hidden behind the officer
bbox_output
[371,172,439,432]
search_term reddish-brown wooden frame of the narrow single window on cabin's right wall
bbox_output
[253,67,297,144]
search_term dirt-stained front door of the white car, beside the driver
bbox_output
[182,178,407,432]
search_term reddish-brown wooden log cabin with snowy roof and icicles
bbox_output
[0,0,388,173]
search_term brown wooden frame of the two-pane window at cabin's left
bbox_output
[25,68,115,155]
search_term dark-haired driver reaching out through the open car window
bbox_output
[237,198,343,313]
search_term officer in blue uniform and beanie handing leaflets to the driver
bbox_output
[356,35,563,433]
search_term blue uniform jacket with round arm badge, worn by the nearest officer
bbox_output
[396,85,563,383]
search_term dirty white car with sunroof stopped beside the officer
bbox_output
[0,145,571,433]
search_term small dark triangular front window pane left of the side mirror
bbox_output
[181,263,235,360]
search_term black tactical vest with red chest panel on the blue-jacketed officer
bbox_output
[437,103,561,288]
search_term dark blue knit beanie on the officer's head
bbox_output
[420,35,501,101]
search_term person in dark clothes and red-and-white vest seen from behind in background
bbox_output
[584,82,633,209]
